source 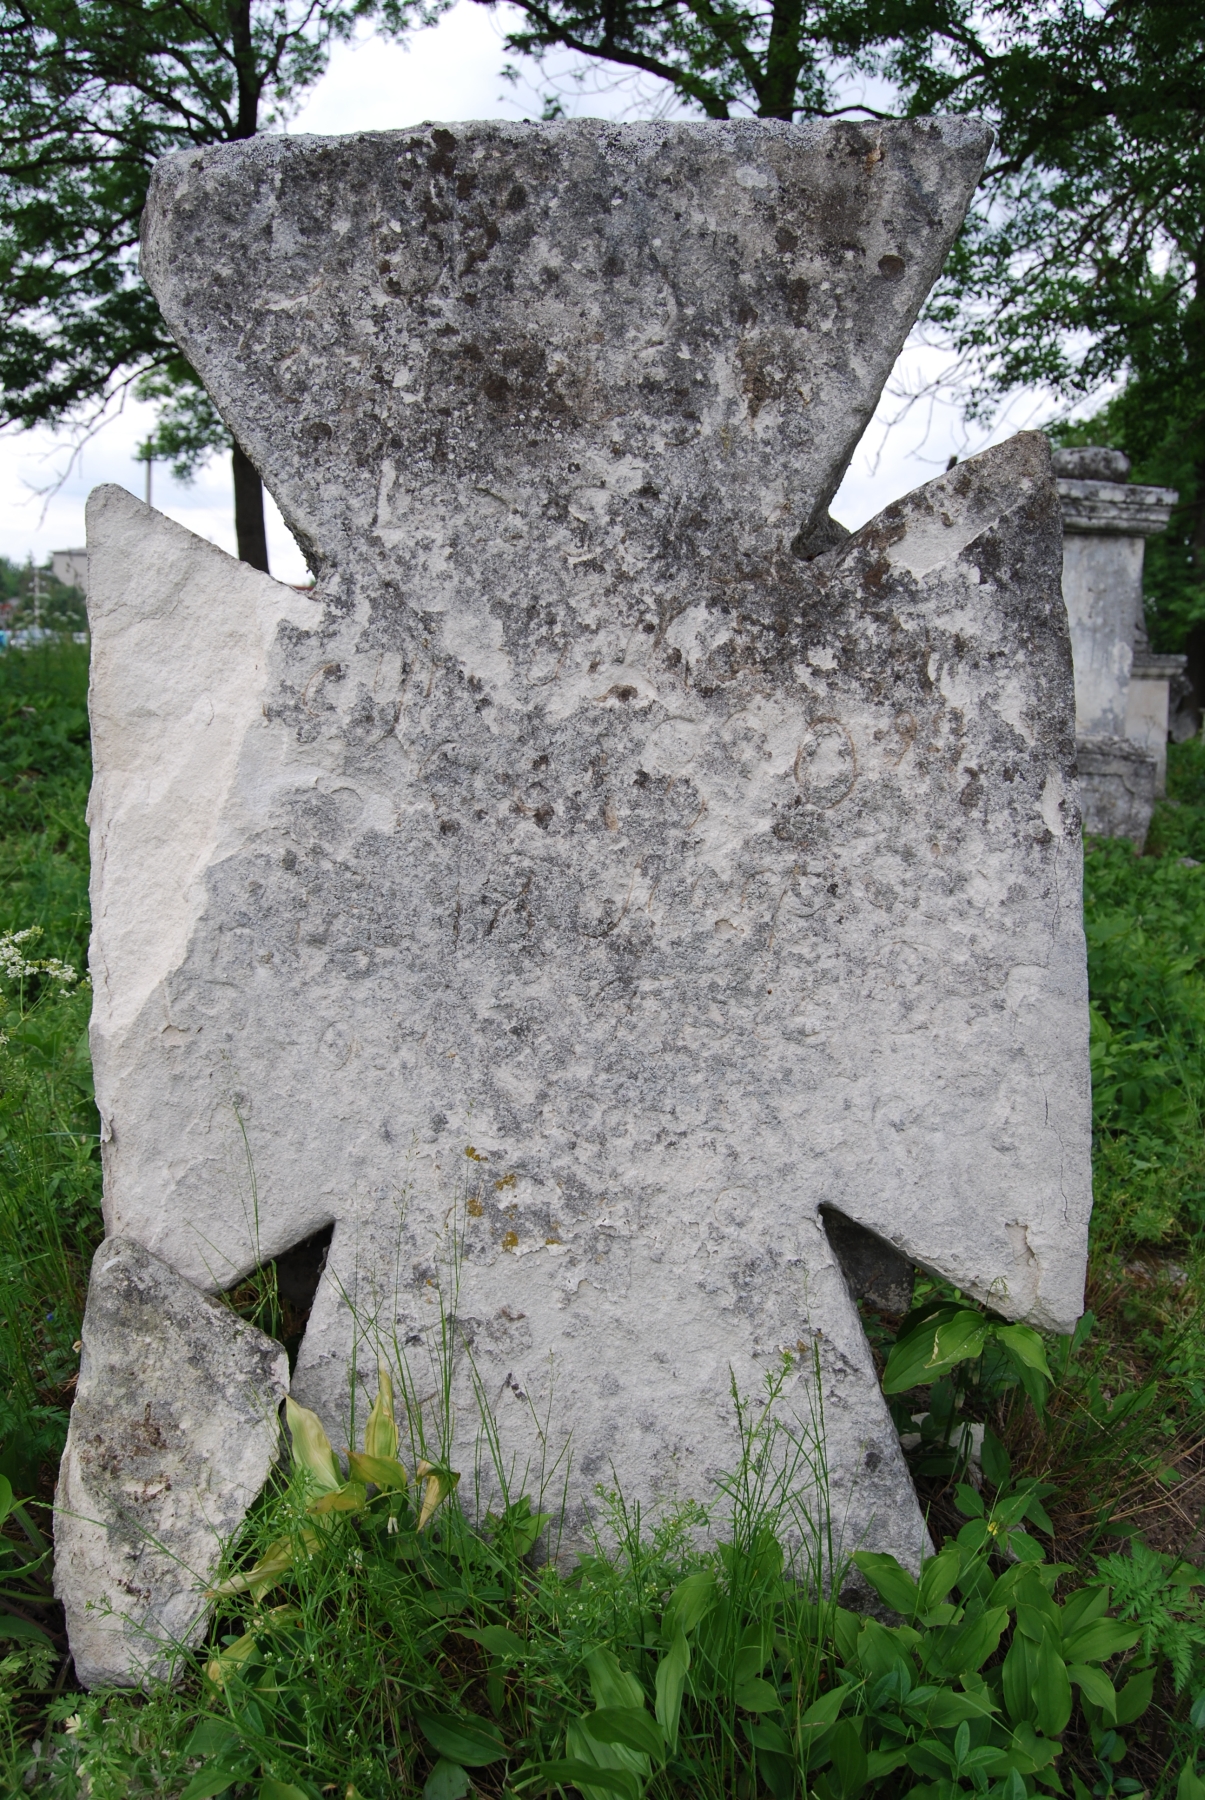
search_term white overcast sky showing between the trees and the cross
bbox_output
[0,0,1048,581]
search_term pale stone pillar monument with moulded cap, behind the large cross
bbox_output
[1054,446,1183,848]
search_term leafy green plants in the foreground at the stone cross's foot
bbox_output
[13,1370,1205,1800]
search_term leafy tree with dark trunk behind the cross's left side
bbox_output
[0,0,432,569]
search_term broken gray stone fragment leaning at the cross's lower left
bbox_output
[54,1238,288,1687]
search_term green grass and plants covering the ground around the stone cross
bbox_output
[0,644,1205,1800]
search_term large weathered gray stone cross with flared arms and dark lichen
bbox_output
[56,119,1090,1677]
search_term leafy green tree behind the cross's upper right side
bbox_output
[485,0,1205,673]
